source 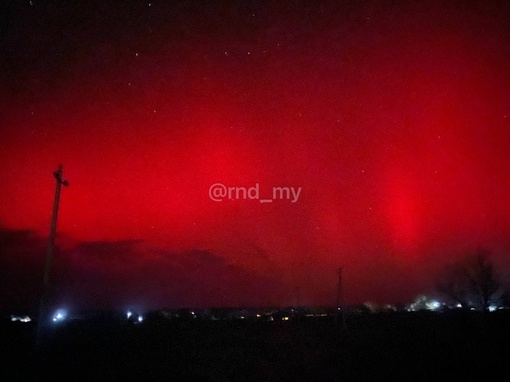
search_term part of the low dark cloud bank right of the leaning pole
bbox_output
[33,240,284,308]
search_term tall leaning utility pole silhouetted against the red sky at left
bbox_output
[37,164,69,342]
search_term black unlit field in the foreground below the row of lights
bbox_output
[1,311,510,381]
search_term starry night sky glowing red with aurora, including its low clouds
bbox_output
[0,0,510,309]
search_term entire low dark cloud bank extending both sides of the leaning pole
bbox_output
[0,228,282,314]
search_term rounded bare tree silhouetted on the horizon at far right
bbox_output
[436,249,502,311]
